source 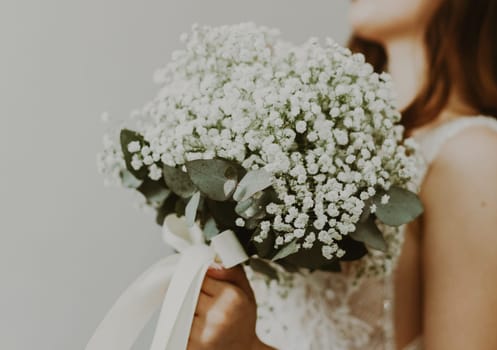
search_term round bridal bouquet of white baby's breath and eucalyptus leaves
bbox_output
[99,23,422,278]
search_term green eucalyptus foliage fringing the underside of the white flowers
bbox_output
[121,153,408,270]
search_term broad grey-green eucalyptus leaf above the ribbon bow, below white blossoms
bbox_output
[185,159,238,201]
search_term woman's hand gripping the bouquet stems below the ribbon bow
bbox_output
[188,266,271,350]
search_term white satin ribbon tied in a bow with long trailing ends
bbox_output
[86,215,248,350]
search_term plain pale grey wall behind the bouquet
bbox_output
[0,0,348,350]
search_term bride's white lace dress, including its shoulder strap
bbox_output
[247,116,497,350]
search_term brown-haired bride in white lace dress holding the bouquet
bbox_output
[188,0,497,350]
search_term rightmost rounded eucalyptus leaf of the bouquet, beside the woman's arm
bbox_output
[373,186,423,226]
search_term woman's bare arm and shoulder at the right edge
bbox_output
[421,128,497,350]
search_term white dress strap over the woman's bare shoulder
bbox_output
[417,116,497,164]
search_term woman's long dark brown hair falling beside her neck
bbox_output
[349,0,497,130]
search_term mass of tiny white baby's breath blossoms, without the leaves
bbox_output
[98,23,415,259]
